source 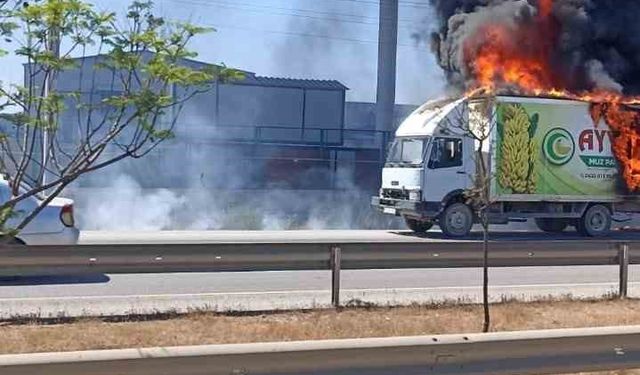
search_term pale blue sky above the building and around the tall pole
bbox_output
[0,0,445,105]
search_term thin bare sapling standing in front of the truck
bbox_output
[444,96,497,332]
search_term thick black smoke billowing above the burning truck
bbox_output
[421,0,640,95]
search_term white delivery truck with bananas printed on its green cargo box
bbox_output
[372,96,640,237]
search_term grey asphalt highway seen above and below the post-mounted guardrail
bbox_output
[0,231,640,318]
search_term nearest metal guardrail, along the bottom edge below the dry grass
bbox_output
[0,326,640,375]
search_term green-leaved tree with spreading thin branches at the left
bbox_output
[0,0,242,238]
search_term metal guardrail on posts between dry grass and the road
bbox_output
[0,240,640,306]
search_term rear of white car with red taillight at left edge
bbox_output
[0,177,80,245]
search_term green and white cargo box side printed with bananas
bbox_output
[488,97,631,201]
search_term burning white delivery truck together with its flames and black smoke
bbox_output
[373,0,640,237]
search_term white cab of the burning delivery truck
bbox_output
[372,99,475,236]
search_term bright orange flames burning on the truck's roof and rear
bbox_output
[463,0,640,192]
